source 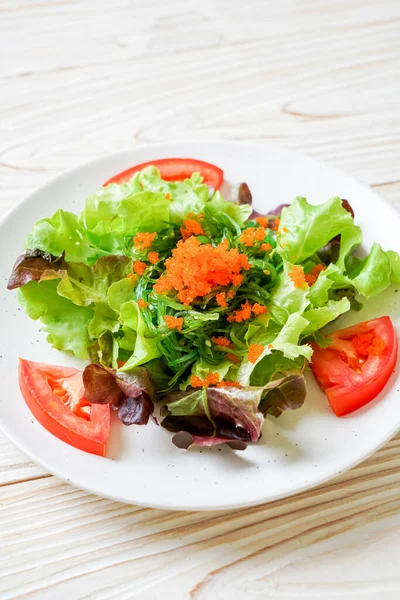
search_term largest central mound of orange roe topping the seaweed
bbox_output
[154,237,250,305]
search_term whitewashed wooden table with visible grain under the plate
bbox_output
[0,0,400,600]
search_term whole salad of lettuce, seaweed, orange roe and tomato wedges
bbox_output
[8,159,400,455]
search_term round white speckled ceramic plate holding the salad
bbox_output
[0,142,400,510]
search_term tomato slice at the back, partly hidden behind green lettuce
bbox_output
[103,158,224,190]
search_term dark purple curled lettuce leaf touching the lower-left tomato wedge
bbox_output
[83,364,154,425]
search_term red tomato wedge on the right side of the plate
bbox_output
[311,317,398,417]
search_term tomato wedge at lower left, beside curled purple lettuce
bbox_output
[19,359,110,456]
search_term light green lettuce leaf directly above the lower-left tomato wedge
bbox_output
[18,281,93,359]
